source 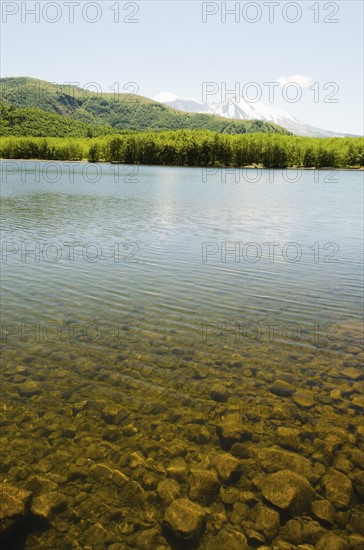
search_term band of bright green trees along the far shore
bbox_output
[0,130,364,168]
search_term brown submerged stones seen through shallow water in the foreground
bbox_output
[0,322,364,550]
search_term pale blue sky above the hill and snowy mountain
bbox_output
[1,0,363,134]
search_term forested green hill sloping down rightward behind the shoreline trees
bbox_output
[0,77,290,137]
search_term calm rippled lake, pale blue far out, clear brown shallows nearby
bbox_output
[1,161,363,549]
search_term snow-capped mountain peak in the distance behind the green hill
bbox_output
[165,98,345,137]
